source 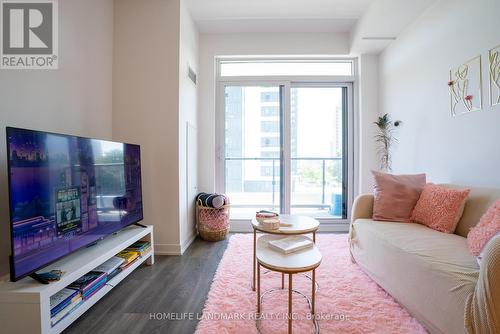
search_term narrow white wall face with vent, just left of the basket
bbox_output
[179,1,199,252]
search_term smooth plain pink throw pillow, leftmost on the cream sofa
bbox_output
[372,171,426,223]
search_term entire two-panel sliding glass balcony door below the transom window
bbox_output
[221,82,350,219]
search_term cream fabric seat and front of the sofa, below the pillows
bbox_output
[351,219,479,333]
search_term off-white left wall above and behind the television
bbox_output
[0,0,113,274]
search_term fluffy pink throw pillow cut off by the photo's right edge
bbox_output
[467,200,500,256]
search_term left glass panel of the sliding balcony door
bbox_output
[224,85,283,218]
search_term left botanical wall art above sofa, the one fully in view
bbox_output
[448,56,483,116]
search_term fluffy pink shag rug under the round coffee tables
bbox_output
[196,234,427,334]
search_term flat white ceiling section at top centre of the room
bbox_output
[186,0,375,33]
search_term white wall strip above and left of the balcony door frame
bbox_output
[198,33,349,192]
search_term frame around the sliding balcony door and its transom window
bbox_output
[215,57,359,225]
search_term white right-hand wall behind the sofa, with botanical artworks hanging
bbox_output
[380,0,500,187]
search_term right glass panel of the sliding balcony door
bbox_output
[290,85,347,218]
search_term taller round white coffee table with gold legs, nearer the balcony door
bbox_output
[252,215,319,291]
